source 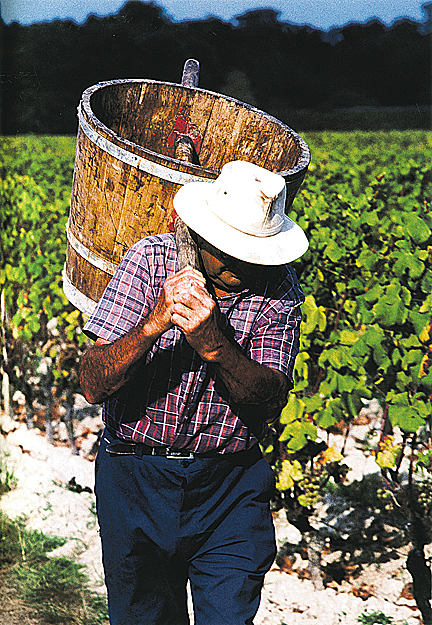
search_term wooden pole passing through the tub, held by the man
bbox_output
[174,59,201,271]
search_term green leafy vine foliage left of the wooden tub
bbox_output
[0,136,75,341]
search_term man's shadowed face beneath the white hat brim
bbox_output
[197,235,257,296]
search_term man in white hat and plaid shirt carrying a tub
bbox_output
[81,161,308,625]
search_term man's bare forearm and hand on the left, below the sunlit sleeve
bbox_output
[80,267,205,404]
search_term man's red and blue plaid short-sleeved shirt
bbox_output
[84,234,304,453]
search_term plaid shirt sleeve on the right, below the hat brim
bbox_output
[249,272,304,382]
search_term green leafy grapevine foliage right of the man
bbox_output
[282,132,432,449]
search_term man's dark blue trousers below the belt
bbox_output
[96,434,276,625]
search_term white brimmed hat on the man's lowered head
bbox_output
[173,161,309,265]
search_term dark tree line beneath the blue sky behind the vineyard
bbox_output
[0,0,432,134]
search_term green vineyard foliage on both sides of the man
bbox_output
[0,131,432,472]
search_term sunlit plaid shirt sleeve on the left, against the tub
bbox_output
[84,242,154,342]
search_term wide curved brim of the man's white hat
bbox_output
[173,182,309,265]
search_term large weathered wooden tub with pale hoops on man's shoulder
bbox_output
[63,79,310,314]
